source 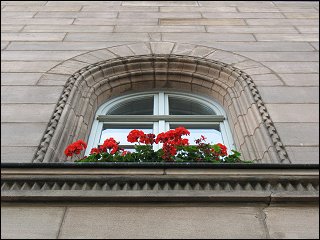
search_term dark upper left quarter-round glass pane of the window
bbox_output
[107,96,153,115]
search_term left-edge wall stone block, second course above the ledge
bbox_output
[1,123,47,147]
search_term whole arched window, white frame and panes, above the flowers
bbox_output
[85,91,234,155]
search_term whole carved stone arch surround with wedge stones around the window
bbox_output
[33,42,290,163]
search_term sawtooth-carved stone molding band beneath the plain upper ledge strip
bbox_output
[1,174,319,204]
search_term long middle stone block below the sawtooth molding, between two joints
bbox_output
[60,206,266,239]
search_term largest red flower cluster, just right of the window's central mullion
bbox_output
[155,127,190,161]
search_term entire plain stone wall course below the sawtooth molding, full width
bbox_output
[1,204,319,239]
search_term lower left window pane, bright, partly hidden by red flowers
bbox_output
[99,124,153,146]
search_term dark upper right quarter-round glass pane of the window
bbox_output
[169,96,216,115]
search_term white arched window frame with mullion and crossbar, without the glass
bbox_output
[85,91,235,156]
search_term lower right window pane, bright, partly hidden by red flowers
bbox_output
[170,125,223,145]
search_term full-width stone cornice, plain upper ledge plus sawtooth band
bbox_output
[1,166,319,204]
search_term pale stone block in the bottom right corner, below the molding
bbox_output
[264,207,319,239]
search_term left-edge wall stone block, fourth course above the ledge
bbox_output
[1,86,63,104]
